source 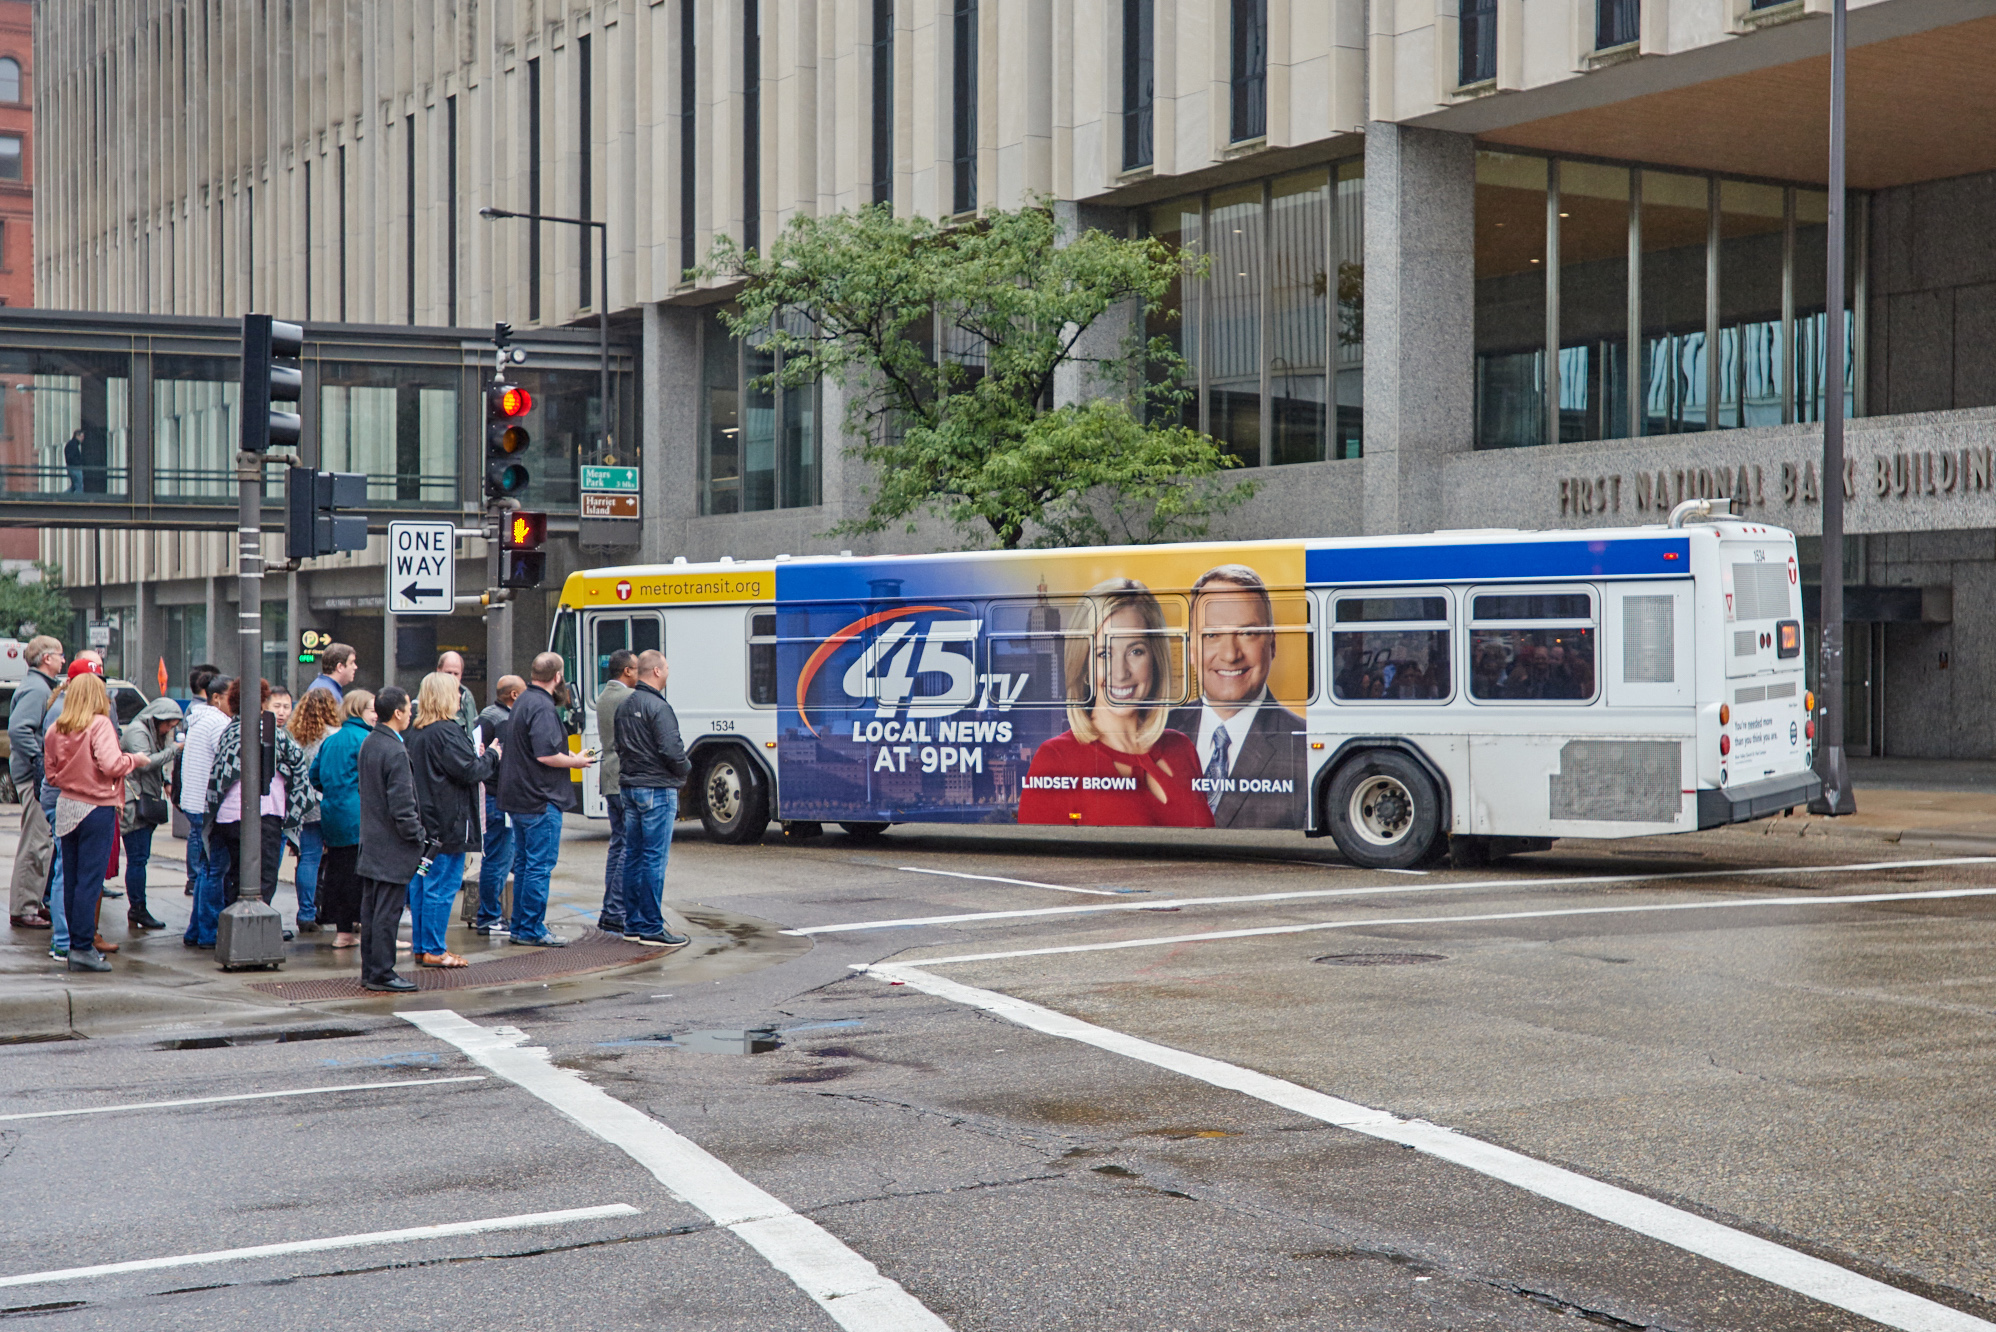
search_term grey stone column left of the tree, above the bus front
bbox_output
[639,304,701,563]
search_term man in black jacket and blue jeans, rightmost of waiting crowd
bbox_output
[609,649,693,949]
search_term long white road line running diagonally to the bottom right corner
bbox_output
[866,963,1996,1332]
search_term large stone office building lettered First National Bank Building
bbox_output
[36,0,1996,757]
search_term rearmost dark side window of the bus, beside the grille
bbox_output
[1469,589,1597,703]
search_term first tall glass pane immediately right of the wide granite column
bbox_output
[1475,152,1547,449]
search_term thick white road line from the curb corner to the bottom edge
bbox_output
[399,1008,950,1332]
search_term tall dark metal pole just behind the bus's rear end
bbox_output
[1808,0,1858,815]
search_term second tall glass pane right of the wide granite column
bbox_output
[1559,162,1629,441]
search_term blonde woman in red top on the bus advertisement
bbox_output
[1018,579,1214,829]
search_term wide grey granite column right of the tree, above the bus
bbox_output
[1363,120,1477,533]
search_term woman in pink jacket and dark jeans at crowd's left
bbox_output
[44,675,146,971]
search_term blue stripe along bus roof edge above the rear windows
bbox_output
[1303,537,1691,585]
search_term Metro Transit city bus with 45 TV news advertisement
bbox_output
[551,501,1820,869]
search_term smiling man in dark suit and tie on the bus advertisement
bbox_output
[1172,565,1307,829]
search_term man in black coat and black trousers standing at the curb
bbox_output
[359,685,427,995]
